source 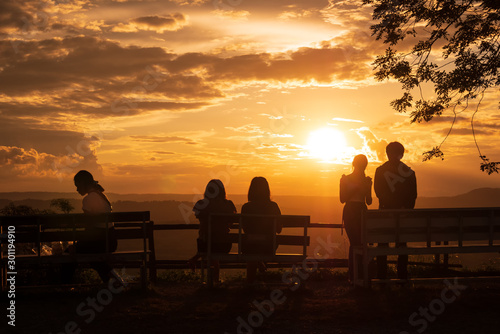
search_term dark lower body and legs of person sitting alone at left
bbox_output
[61,228,118,284]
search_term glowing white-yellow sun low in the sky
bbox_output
[307,128,347,161]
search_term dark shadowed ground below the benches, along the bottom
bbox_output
[0,276,500,334]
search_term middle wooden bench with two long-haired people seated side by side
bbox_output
[204,214,310,286]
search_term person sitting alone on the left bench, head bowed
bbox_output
[62,170,118,283]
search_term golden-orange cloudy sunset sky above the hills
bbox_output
[0,0,500,196]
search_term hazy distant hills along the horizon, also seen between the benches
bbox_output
[0,188,500,268]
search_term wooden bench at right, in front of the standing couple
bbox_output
[354,208,500,287]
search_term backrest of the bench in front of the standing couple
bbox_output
[362,208,500,245]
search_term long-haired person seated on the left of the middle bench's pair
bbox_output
[188,179,236,282]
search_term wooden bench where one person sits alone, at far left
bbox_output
[0,211,156,291]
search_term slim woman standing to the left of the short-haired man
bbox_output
[340,154,372,282]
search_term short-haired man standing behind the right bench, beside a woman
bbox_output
[374,142,417,279]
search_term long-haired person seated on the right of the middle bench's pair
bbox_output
[241,176,282,283]
